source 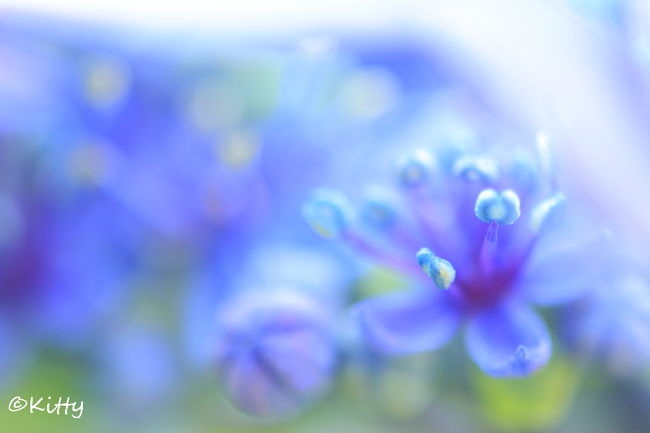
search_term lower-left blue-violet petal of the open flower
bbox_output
[356,290,459,354]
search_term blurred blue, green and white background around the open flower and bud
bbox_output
[0,0,650,433]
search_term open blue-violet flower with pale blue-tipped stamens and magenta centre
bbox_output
[303,133,606,377]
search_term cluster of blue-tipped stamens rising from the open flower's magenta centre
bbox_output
[303,139,564,304]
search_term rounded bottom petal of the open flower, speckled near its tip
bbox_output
[465,305,551,377]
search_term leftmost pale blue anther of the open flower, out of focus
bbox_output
[302,188,354,239]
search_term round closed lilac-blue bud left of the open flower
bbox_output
[217,289,337,416]
